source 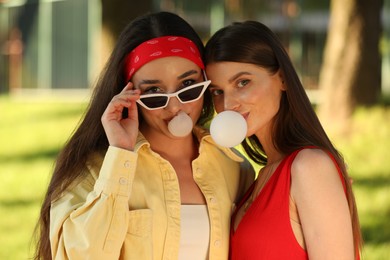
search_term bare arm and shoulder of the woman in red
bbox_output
[291,149,354,259]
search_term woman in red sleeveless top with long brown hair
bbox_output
[206,21,362,259]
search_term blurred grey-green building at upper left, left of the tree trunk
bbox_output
[0,0,100,92]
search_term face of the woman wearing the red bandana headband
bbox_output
[132,57,204,137]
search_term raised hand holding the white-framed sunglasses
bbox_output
[101,82,140,151]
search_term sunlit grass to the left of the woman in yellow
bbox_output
[0,97,86,259]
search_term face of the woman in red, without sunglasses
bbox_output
[206,62,284,136]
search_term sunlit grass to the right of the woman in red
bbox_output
[335,107,390,260]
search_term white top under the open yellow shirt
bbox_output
[179,205,210,260]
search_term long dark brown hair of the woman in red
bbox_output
[205,21,362,253]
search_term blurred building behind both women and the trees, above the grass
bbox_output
[0,0,390,96]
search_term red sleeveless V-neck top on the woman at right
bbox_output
[230,150,345,260]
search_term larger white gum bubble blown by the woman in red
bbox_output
[210,111,247,147]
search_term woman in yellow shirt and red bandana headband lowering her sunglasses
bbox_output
[32,12,254,260]
